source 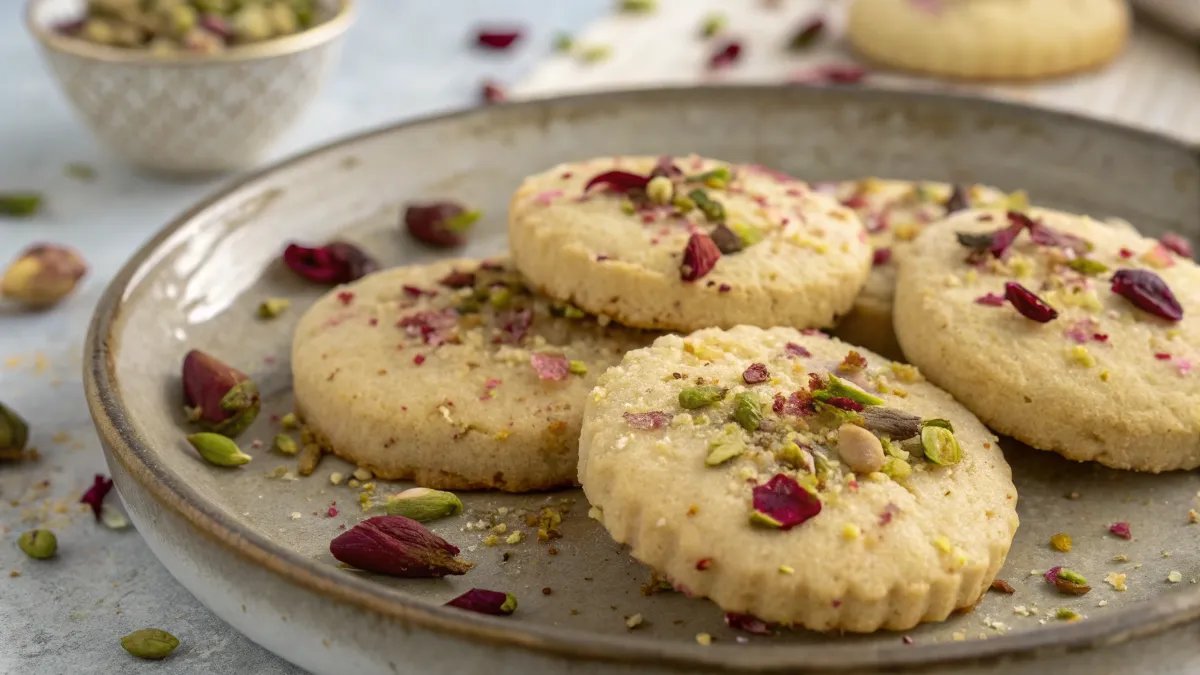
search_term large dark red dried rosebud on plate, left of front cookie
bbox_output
[329,515,472,578]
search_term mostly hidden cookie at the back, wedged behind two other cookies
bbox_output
[815,178,1012,359]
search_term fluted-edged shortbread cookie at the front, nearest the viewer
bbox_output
[580,325,1018,632]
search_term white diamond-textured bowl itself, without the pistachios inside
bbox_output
[25,0,353,173]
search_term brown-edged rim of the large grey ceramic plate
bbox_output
[83,84,1200,673]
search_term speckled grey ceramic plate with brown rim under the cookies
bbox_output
[86,88,1200,675]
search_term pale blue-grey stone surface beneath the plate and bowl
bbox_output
[0,0,610,675]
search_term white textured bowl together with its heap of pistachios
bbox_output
[25,0,353,173]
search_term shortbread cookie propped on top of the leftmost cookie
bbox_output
[509,156,871,330]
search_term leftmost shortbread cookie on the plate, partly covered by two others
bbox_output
[292,259,654,491]
